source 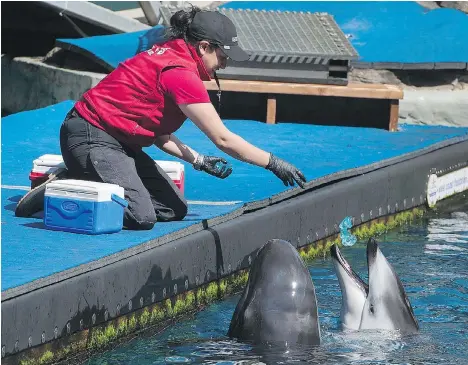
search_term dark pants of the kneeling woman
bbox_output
[60,109,187,229]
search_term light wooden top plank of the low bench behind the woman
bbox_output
[205,80,403,99]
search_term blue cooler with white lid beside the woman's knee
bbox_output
[44,180,128,234]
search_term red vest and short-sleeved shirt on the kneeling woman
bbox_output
[75,39,210,148]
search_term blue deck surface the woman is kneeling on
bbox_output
[2,101,468,291]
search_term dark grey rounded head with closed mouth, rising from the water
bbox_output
[228,239,320,347]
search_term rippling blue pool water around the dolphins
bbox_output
[85,196,468,365]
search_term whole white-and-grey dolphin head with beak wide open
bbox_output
[331,238,419,333]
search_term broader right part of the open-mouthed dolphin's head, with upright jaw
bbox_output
[360,238,419,333]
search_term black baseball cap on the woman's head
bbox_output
[190,11,250,61]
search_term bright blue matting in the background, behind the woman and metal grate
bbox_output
[56,1,468,68]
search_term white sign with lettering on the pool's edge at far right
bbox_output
[427,167,468,208]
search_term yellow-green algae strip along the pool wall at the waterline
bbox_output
[12,208,425,365]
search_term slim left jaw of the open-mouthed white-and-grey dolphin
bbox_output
[330,245,369,330]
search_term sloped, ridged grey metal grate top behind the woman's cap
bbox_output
[219,9,358,63]
